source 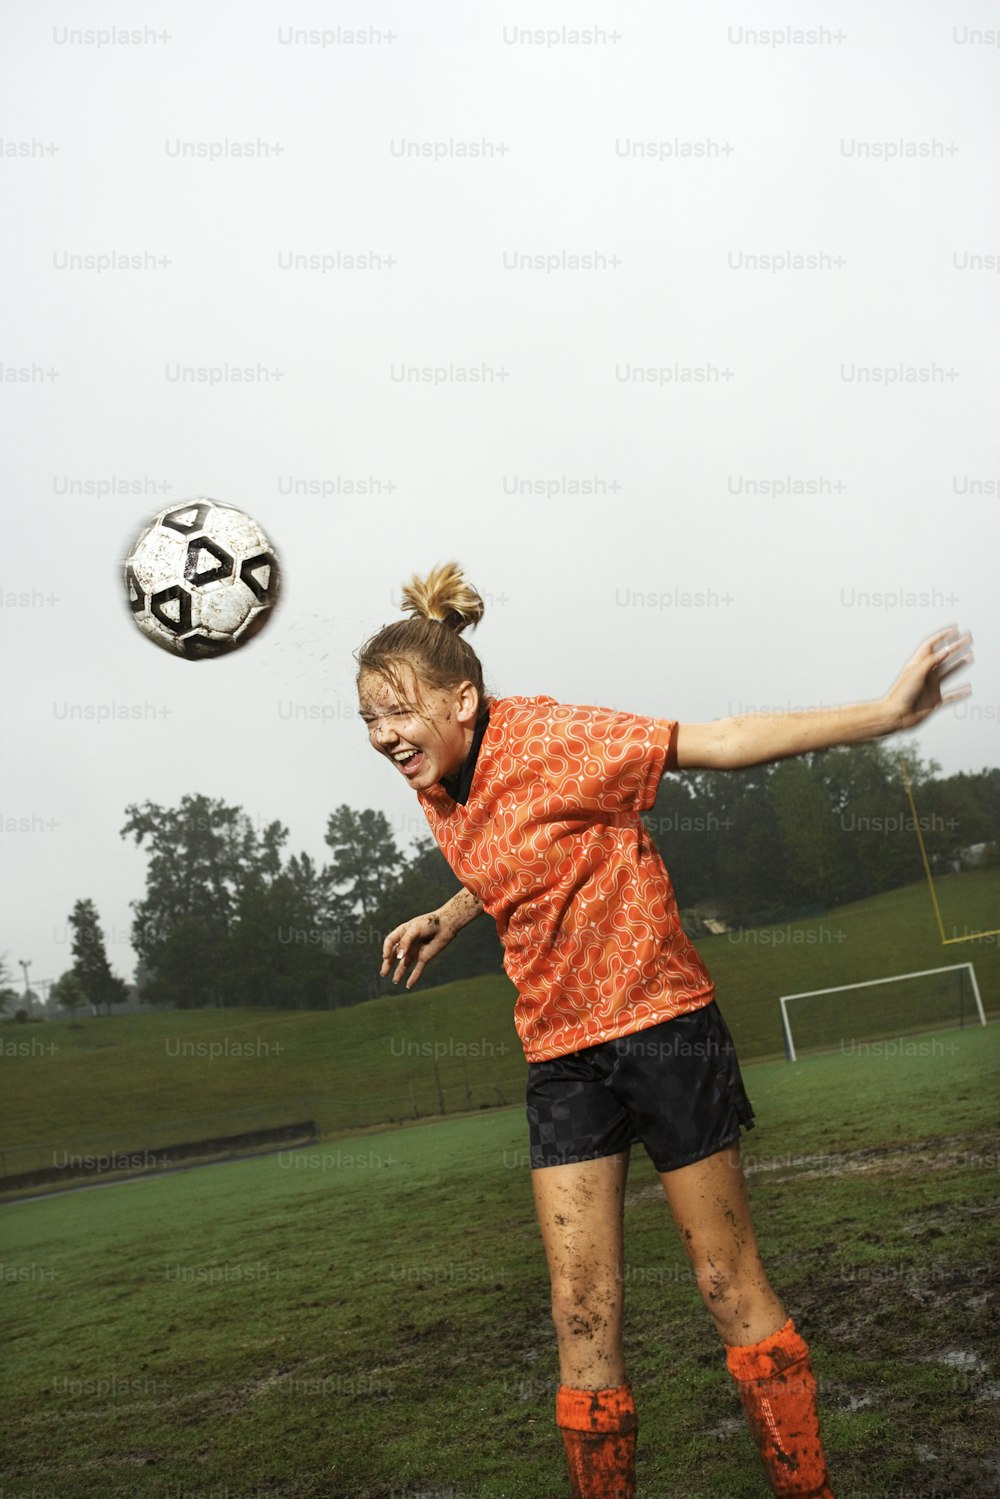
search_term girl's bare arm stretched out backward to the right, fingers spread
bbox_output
[676,625,972,770]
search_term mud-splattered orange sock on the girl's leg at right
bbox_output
[726,1318,834,1499]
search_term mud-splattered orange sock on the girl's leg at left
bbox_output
[556,1385,639,1499]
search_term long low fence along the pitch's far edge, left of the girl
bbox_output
[0,1070,525,1192]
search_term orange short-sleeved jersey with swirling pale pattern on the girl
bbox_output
[417,697,715,1061]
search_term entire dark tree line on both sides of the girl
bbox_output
[41,742,1000,1009]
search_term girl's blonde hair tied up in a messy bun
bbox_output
[354,562,490,721]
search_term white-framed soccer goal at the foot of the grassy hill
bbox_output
[778,962,987,1061]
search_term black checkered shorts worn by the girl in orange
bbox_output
[525,1000,754,1171]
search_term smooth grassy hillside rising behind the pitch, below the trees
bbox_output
[0,869,1000,1174]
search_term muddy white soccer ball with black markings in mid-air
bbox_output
[124,495,280,661]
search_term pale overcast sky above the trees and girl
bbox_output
[0,0,1000,980]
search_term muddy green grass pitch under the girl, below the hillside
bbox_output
[0,1027,1000,1499]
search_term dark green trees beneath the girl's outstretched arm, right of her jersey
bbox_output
[656,741,1000,935]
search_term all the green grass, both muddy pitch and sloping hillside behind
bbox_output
[0,871,1000,1499]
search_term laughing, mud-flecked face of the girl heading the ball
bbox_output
[358,667,478,791]
